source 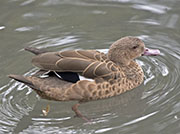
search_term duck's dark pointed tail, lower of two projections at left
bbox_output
[8,74,35,88]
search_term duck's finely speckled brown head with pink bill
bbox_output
[108,36,160,66]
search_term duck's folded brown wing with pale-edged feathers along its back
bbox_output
[32,50,118,78]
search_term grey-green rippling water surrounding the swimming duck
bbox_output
[0,0,180,134]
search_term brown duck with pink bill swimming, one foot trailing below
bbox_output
[9,36,160,121]
